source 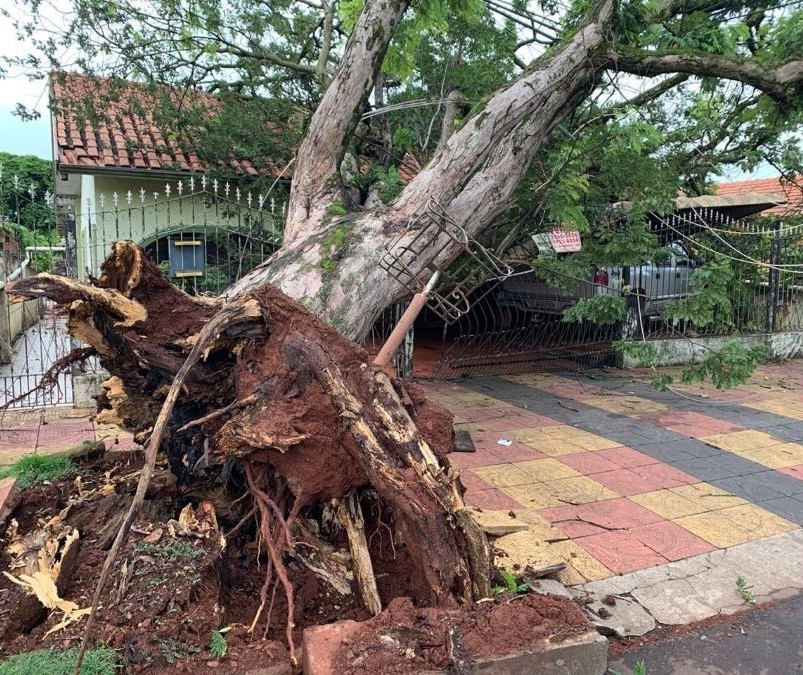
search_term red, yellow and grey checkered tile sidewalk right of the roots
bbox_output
[425,361,803,623]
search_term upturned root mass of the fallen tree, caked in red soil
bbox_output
[13,242,489,654]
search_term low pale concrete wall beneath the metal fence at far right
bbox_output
[617,330,803,368]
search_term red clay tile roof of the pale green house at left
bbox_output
[50,73,258,176]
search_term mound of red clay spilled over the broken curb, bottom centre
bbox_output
[335,594,589,675]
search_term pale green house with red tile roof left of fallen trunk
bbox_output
[50,73,421,292]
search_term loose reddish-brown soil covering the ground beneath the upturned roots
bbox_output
[0,451,588,674]
